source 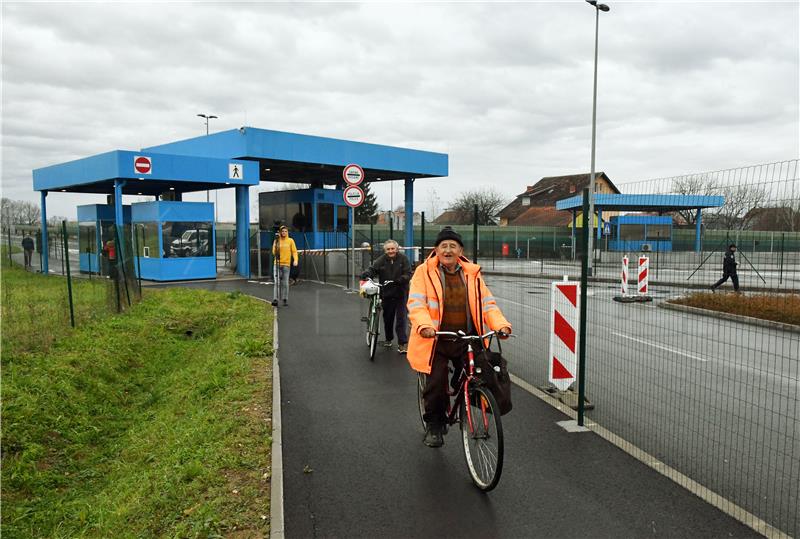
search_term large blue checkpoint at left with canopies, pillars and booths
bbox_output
[33,127,448,281]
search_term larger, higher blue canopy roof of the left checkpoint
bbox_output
[145,127,448,184]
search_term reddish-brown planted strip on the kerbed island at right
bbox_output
[669,292,800,326]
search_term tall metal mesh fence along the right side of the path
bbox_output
[462,161,800,536]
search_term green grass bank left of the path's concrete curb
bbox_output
[2,268,272,537]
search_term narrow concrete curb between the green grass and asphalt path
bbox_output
[269,307,284,539]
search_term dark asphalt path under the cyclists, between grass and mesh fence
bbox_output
[167,281,758,538]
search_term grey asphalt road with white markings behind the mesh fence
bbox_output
[487,276,800,535]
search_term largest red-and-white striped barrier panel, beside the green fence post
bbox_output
[548,281,580,391]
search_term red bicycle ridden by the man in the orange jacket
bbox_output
[417,331,513,491]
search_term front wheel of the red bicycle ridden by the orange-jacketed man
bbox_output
[460,386,503,491]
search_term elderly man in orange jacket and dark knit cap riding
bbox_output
[408,227,511,447]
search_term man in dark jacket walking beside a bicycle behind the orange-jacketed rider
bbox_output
[361,240,411,354]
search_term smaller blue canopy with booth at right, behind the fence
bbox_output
[556,193,725,252]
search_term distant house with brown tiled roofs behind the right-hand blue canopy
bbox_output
[498,172,620,226]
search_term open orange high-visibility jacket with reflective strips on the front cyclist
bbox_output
[407,252,511,374]
